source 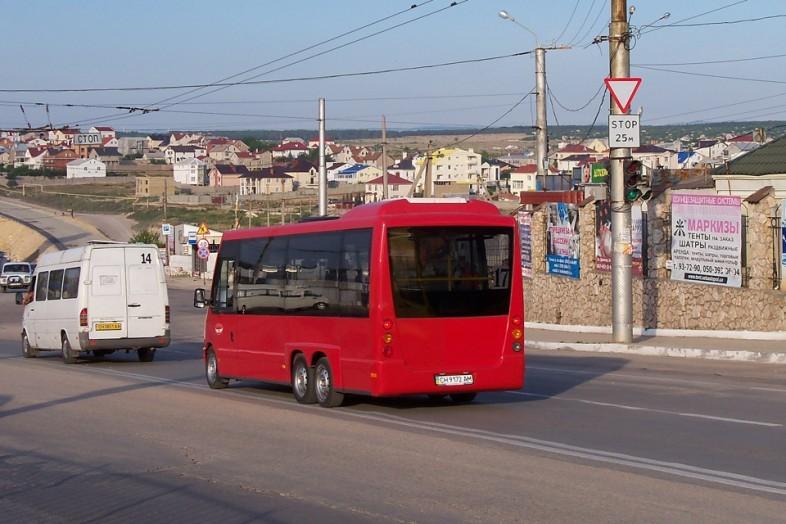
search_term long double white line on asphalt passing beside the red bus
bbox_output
[66,369,786,496]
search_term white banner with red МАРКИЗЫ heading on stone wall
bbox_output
[671,191,742,287]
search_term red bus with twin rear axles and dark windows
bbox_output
[194,199,524,407]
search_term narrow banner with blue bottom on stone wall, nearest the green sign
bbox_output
[546,203,581,278]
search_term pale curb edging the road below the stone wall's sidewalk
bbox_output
[526,340,786,364]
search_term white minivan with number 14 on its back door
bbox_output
[20,242,170,364]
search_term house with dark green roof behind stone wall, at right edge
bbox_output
[712,137,786,200]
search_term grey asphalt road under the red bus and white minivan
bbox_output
[0,283,786,522]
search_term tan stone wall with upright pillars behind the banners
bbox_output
[524,191,786,331]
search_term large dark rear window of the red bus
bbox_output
[388,227,512,318]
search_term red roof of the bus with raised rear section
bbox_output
[223,198,513,241]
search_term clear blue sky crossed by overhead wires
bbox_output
[0,0,786,131]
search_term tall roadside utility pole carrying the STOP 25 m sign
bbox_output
[609,0,633,343]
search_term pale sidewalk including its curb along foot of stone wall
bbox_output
[524,324,786,364]
